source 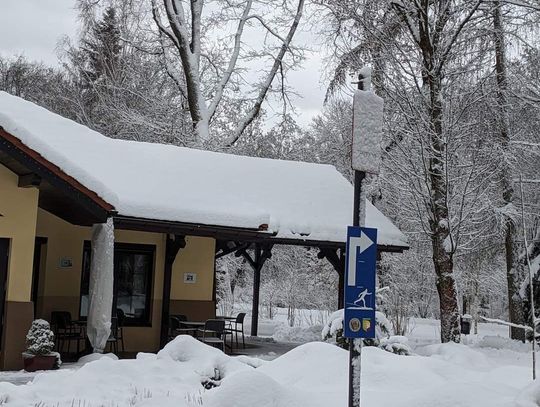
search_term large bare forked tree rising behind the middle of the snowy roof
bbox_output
[152,0,305,146]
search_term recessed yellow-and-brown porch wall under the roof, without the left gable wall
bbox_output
[37,209,215,352]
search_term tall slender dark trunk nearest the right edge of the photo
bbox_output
[493,1,525,340]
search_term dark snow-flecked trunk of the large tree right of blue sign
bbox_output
[391,0,480,342]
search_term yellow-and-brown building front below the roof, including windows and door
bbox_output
[0,164,215,369]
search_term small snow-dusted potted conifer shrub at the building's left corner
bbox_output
[22,319,61,372]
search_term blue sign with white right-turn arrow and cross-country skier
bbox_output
[343,226,377,338]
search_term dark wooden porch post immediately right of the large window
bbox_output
[159,235,186,349]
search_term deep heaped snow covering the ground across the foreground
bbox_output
[0,319,540,407]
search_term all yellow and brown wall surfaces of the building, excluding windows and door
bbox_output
[0,165,215,351]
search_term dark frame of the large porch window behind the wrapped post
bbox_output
[79,240,157,327]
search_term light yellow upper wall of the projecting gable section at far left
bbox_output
[0,164,39,302]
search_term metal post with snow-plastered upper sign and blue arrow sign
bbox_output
[343,68,383,407]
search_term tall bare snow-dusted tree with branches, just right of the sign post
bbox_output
[318,0,489,342]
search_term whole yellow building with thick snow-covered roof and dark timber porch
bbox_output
[0,92,407,369]
